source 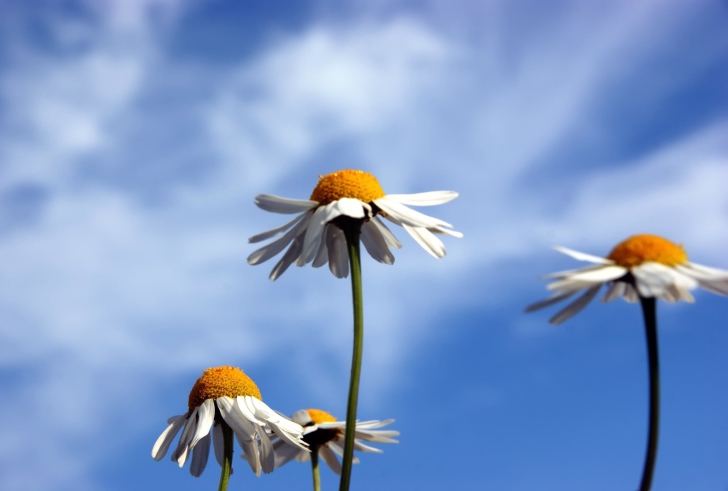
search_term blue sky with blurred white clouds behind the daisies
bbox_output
[0,0,728,491]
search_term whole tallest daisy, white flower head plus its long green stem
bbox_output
[248,169,462,491]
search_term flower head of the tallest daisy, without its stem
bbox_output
[248,169,462,280]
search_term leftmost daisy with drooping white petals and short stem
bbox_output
[152,366,307,490]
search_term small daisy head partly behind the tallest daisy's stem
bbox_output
[273,409,399,474]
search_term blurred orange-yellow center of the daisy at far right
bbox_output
[607,234,688,268]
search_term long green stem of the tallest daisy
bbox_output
[339,220,364,491]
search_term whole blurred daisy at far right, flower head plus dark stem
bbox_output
[526,234,728,491]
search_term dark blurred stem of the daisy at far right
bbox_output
[640,297,660,491]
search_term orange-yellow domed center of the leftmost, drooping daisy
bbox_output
[187,365,263,411]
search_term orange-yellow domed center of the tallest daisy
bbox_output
[311,169,384,206]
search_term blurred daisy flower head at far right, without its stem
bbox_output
[526,234,728,325]
